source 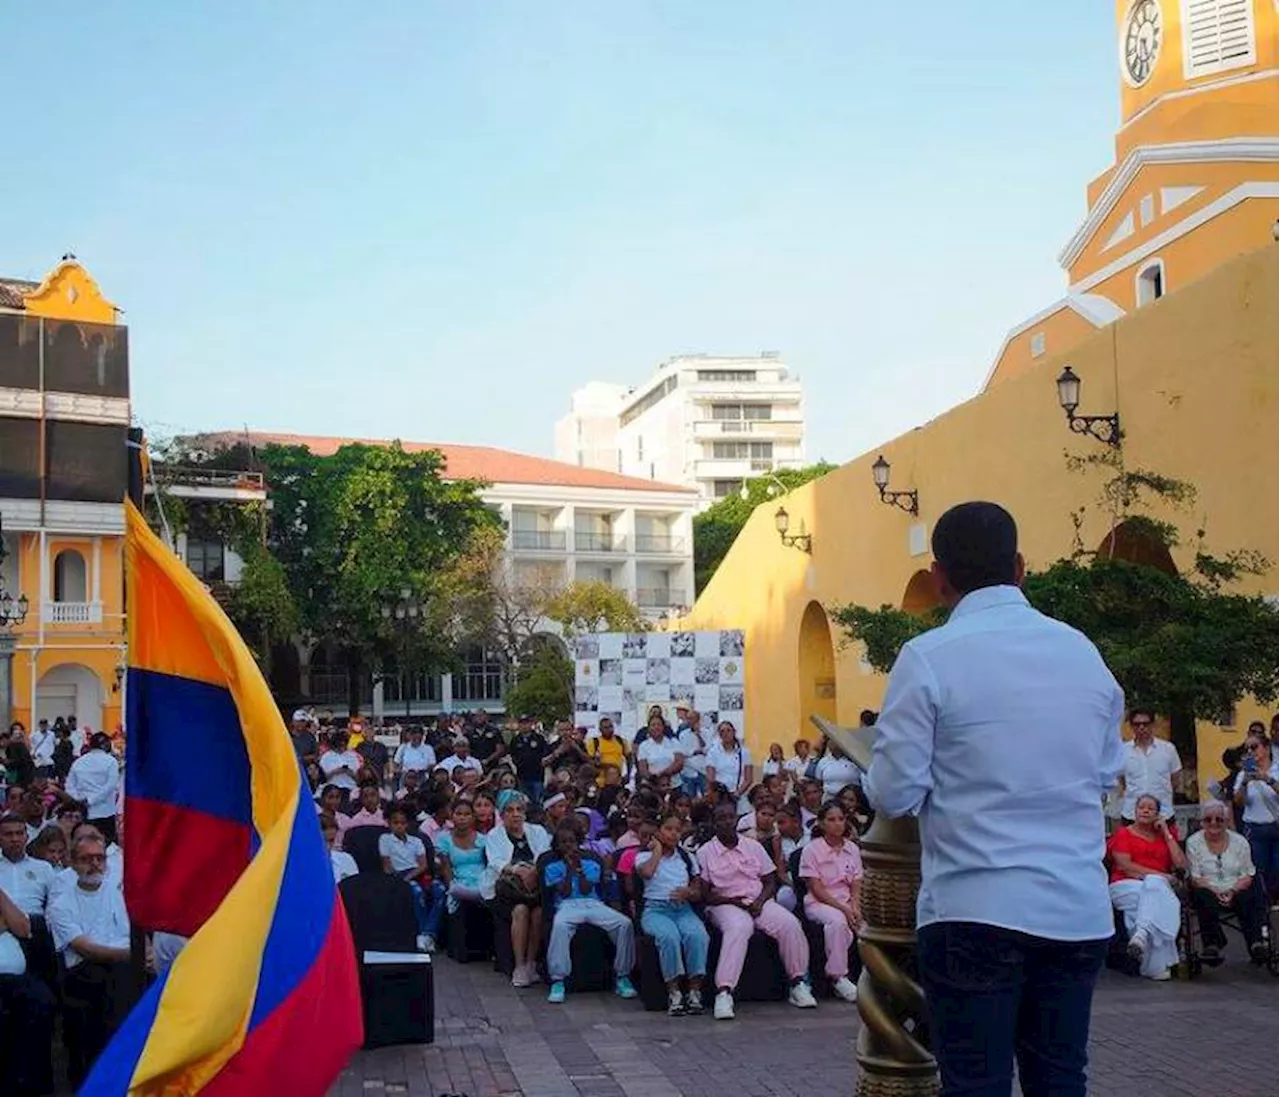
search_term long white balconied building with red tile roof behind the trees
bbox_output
[175,433,698,717]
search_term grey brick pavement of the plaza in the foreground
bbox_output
[330,957,1280,1097]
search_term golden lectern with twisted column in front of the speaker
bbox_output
[810,716,941,1097]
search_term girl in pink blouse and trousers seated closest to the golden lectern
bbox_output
[800,800,863,1002]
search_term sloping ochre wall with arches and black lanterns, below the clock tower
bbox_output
[682,246,1280,793]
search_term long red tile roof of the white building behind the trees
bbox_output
[200,430,694,495]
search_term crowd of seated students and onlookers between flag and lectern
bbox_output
[293,704,874,1019]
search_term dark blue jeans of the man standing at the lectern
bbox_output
[916,922,1107,1097]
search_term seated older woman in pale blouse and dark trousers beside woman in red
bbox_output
[1187,801,1267,966]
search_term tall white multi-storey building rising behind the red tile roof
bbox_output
[556,352,805,507]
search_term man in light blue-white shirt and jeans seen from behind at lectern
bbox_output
[863,503,1124,1097]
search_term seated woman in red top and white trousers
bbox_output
[1108,794,1187,981]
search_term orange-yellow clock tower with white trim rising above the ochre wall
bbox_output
[1061,0,1280,299]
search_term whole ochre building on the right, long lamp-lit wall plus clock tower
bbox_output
[687,0,1280,788]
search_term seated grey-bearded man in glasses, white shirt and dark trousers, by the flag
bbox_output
[49,835,131,1089]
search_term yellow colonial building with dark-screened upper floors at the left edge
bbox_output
[0,256,129,731]
